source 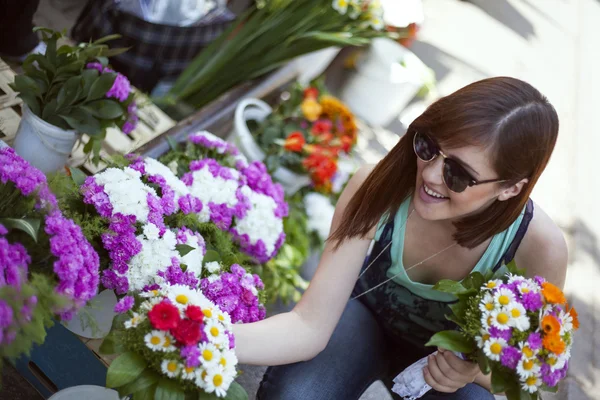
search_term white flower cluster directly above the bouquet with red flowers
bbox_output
[124,228,179,292]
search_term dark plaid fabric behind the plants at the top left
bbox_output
[71,0,235,91]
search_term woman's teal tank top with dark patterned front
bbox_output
[352,198,533,347]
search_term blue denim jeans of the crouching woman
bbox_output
[257,300,494,400]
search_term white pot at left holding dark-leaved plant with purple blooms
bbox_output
[13,105,78,173]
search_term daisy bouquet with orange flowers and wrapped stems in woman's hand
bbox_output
[393,263,579,400]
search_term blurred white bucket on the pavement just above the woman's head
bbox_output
[340,38,427,126]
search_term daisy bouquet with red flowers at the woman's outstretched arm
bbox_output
[100,285,248,400]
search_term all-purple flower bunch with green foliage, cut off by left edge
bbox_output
[0,147,99,358]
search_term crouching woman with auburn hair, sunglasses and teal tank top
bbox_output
[234,77,567,400]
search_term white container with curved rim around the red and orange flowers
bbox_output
[234,99,311,195]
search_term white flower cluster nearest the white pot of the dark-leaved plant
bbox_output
[95,167,156,223]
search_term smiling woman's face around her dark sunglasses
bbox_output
[413,142,508,221]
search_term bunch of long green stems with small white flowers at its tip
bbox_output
[167,0,394,107]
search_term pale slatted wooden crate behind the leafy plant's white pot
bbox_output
[0,59,175,174]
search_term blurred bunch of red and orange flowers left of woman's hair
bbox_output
[253,83,358,194]
